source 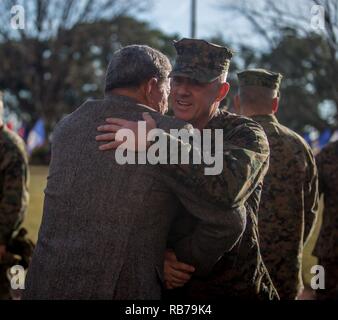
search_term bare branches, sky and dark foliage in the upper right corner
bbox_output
[221,0,338,132]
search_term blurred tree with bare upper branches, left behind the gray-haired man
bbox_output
[0,0,177,131]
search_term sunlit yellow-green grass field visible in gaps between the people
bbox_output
[24,166,322,283]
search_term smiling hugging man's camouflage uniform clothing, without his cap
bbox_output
[163,111,278,300]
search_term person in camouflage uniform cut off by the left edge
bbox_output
[0,93,28,299]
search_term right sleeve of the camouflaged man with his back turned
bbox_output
[304,150,319,243]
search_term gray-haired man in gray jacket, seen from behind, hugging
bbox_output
[23,45,245,299]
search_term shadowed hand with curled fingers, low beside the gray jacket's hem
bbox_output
[164,250,195,289]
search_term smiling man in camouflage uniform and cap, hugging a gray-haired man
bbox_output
[97,39,278,299]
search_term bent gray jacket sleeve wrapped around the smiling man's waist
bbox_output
[163,174,246,276]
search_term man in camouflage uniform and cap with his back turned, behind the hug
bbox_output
[235,69,318,299]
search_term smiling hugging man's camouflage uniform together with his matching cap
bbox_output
[163,39,278,299]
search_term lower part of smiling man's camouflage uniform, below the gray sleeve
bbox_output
[164,210,279,300]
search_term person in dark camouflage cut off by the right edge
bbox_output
[314,141,338,299]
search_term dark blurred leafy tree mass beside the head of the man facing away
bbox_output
[258,29,338,132]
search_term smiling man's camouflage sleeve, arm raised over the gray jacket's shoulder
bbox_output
[163,125,269,208]
